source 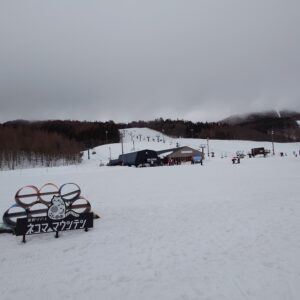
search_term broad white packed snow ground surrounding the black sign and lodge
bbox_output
[0,130,300,300]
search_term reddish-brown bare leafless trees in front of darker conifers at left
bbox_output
[0,126,81,170]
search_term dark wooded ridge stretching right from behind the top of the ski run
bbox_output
[119,117,300,142]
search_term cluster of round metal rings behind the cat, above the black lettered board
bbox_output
[3,183,91,227]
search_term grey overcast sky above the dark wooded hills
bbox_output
[0,0,300,122]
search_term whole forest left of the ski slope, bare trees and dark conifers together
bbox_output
[0,120,119,169]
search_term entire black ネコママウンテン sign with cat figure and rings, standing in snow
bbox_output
[3,183,94,242]
